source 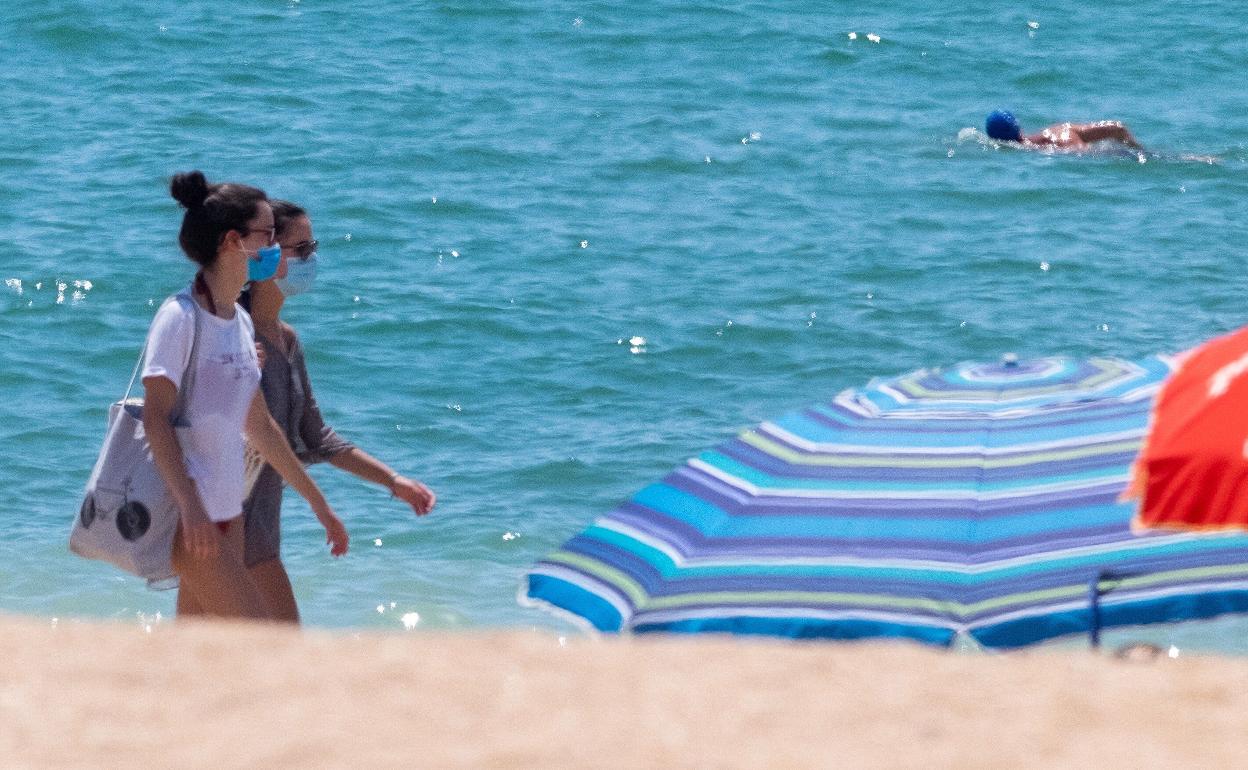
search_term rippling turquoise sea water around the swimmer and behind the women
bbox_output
[0,0,1248,649]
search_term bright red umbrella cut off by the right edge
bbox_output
[1128,327,1248,530]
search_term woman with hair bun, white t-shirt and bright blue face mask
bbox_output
[142,171,348,619]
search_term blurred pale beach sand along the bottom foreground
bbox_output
[0,618,1248,768]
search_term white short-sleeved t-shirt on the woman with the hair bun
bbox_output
[144,288,260,522]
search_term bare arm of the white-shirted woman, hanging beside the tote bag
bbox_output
[144,376,220,559]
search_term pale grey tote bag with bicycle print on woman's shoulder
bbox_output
[70,292,200,588]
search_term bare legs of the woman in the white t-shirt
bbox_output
[173,518,270,620]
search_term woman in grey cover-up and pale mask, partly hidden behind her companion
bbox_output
[240,201,437,623]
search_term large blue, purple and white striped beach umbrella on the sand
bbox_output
[522,357,1248,648]
